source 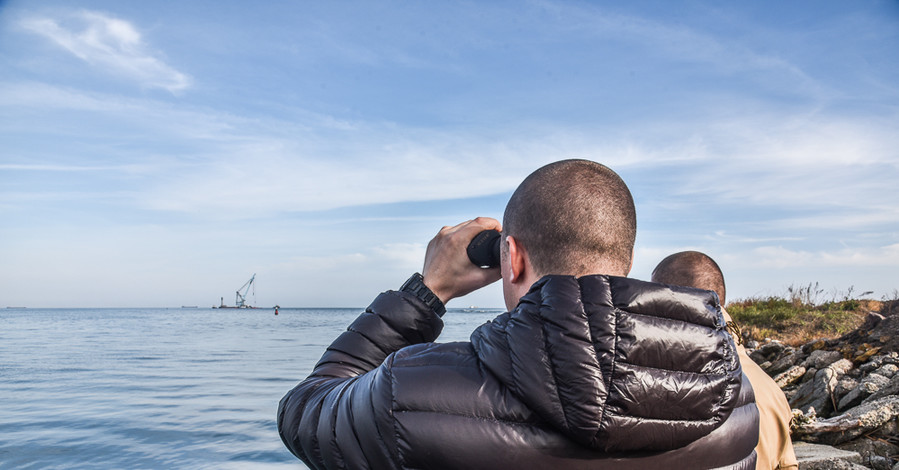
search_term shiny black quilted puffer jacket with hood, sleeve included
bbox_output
[278,276,758,470]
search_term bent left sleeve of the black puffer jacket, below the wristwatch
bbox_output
[278,291,443,469]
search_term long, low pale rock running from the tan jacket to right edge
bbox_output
[795,395,899,445]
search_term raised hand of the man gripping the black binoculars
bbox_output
[422,217,502,304]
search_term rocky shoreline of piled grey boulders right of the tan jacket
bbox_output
[745,301,899,470]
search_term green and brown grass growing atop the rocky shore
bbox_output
[727,283,886,346]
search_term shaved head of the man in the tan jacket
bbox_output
[652,251,726,305]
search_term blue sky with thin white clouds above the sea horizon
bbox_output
[0,0,899,308]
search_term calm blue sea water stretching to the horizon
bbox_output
[0,309,501,469]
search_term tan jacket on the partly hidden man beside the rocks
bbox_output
[721,308,799,470]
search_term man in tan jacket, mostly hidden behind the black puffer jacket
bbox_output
[652,251,799,470]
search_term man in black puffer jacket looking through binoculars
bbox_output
[278,160,758,470]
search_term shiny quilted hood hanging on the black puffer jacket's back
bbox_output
[471,275,742,452]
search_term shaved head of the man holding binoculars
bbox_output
[503,160,637,276]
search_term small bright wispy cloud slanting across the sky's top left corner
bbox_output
[20,11,191,93]
